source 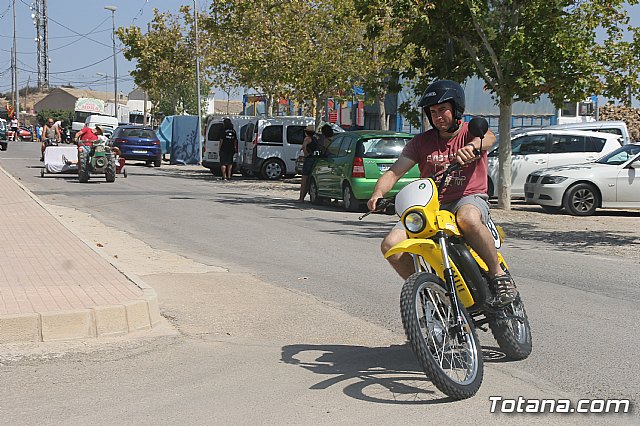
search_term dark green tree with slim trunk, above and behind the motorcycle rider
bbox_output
[396,0,638,209]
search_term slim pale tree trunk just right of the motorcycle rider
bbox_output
[497,101,513,210]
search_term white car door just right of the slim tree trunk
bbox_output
[511,133,549,197]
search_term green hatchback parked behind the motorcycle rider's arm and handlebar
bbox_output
[309,130,420,212]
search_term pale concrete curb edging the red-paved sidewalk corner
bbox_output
[0,167,162,343]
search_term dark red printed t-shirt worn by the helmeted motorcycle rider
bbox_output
[402,123,487,203]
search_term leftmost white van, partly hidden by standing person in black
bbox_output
[202,114,256,175]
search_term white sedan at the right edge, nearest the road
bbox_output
[525,144,640,216]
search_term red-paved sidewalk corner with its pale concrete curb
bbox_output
[0,168,161,343]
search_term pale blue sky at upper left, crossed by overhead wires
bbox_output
[0,0,640,103]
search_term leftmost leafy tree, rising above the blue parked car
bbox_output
[117,6,210,115]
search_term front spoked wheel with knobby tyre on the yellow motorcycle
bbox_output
[400,272,483,399]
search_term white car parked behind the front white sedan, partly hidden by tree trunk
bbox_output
[487,129,622,198]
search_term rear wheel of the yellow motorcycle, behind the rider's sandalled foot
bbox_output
[489,297,532,360]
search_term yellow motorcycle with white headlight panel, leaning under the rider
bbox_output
[362,118,532,399]
